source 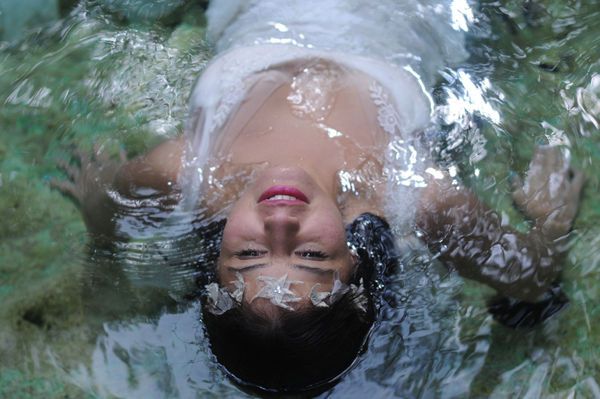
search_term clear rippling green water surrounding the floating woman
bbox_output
[0,0,600,398]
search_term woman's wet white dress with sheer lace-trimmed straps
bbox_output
[182,0,466,231]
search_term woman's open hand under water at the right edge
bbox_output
[513,146,584,240]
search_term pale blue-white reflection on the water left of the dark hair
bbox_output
[68,304,220,398]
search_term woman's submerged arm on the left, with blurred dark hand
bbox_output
[51,138,183,242]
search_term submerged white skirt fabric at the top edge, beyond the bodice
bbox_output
[207,0,466,86]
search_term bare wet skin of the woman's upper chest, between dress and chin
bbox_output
[215,67,387,220]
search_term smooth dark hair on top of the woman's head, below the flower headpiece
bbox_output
[203,294,374,393]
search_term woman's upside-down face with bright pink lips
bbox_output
[218,167,355,301]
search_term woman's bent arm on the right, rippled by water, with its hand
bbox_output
[417,147,583,302]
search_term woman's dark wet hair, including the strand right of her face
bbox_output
[197,213,398,394]
